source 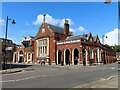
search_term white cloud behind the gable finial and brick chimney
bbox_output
[33,14,73,26]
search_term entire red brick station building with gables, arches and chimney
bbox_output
[13,17,116,65]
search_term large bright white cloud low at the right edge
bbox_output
[104,28,120,45]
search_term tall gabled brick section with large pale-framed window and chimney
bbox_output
[34,20,70,63]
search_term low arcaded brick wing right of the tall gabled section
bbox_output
[57,33,116,65]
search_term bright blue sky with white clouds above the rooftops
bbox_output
[0,2,118,45]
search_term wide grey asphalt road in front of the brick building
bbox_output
[0,63,118,88]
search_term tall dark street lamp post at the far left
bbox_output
[3,16,16,70]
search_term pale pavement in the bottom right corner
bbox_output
[74,76,120,88]
